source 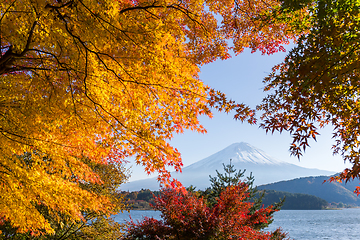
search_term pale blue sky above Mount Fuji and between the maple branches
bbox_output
[126,47,350,180]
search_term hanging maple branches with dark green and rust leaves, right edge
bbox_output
[258,0,360,191]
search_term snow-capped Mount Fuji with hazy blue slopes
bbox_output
[121,142,335,191]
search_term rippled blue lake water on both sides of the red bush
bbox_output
[115,208,360,240]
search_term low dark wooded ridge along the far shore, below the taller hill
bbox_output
[262,190,328,210]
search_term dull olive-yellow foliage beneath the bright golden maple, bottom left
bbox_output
[0,154,128,240]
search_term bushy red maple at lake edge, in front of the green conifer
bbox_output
[124,182,285,240]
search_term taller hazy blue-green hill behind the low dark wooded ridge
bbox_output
[258,176,360,206]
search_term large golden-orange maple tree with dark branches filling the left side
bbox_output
[0,0,306,234]
